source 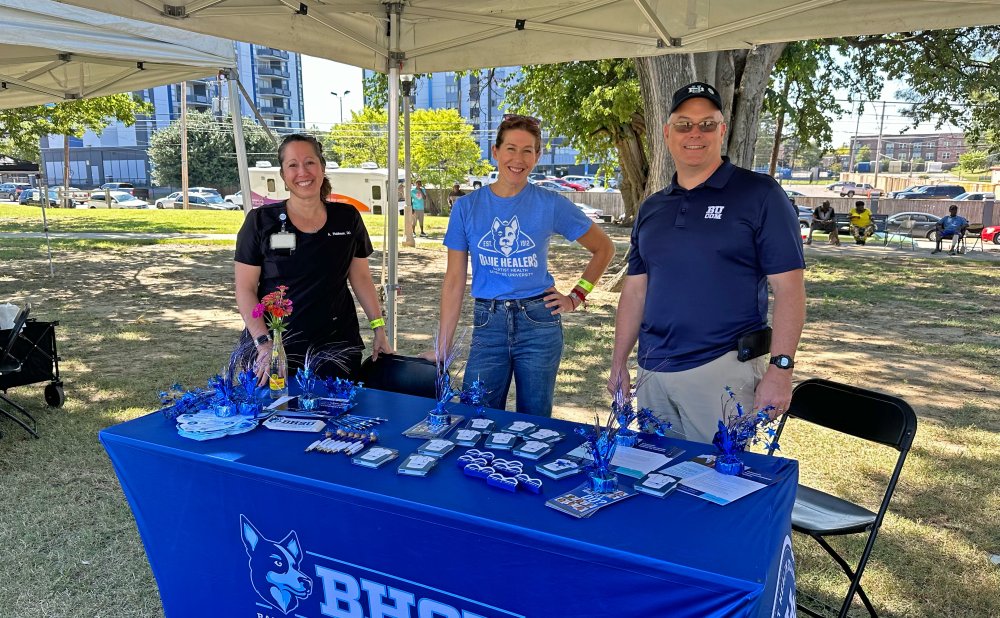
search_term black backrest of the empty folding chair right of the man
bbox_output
[778,378,917,452]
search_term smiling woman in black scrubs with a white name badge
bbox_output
[235,133,392,384]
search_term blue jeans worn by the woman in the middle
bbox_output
[465,297,563,416]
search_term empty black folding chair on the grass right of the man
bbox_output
[769,379,917,618]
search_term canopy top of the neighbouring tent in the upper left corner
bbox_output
[0,0,236,109]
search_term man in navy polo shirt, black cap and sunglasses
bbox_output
[608,82,805,442]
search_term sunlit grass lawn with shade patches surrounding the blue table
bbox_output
[0,220,1000,618]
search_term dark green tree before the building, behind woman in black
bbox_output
[148,112,277,187]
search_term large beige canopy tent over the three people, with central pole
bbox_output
[48,0,1000,344]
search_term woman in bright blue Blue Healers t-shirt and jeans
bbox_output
[438,114,615,416]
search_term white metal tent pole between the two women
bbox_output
[385,2,403,349]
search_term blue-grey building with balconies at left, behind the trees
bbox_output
[41,42,305,188]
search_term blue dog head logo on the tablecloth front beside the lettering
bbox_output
[240,514,312,614]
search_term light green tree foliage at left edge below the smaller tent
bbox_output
[0,93,153,161]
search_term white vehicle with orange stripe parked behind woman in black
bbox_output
[250,161,405,215]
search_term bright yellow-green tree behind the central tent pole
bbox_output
[323,107,491,187]
